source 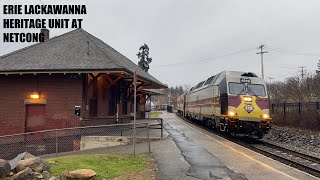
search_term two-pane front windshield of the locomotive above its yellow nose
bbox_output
[229,83,266,96]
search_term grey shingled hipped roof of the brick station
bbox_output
[0,28,166,88]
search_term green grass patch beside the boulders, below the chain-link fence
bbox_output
[46,154,148,179]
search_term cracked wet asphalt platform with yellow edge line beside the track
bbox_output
[152,112,317,180]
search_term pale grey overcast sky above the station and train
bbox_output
[0,0,320,85]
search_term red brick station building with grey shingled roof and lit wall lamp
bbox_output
[0,29,166,135]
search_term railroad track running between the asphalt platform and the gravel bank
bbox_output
[177,115,320,177]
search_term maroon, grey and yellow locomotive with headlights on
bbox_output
[177,71,271,139]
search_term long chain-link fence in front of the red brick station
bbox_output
[0,119,162,159]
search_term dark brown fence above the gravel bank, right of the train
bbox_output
[271,102,320,130]
